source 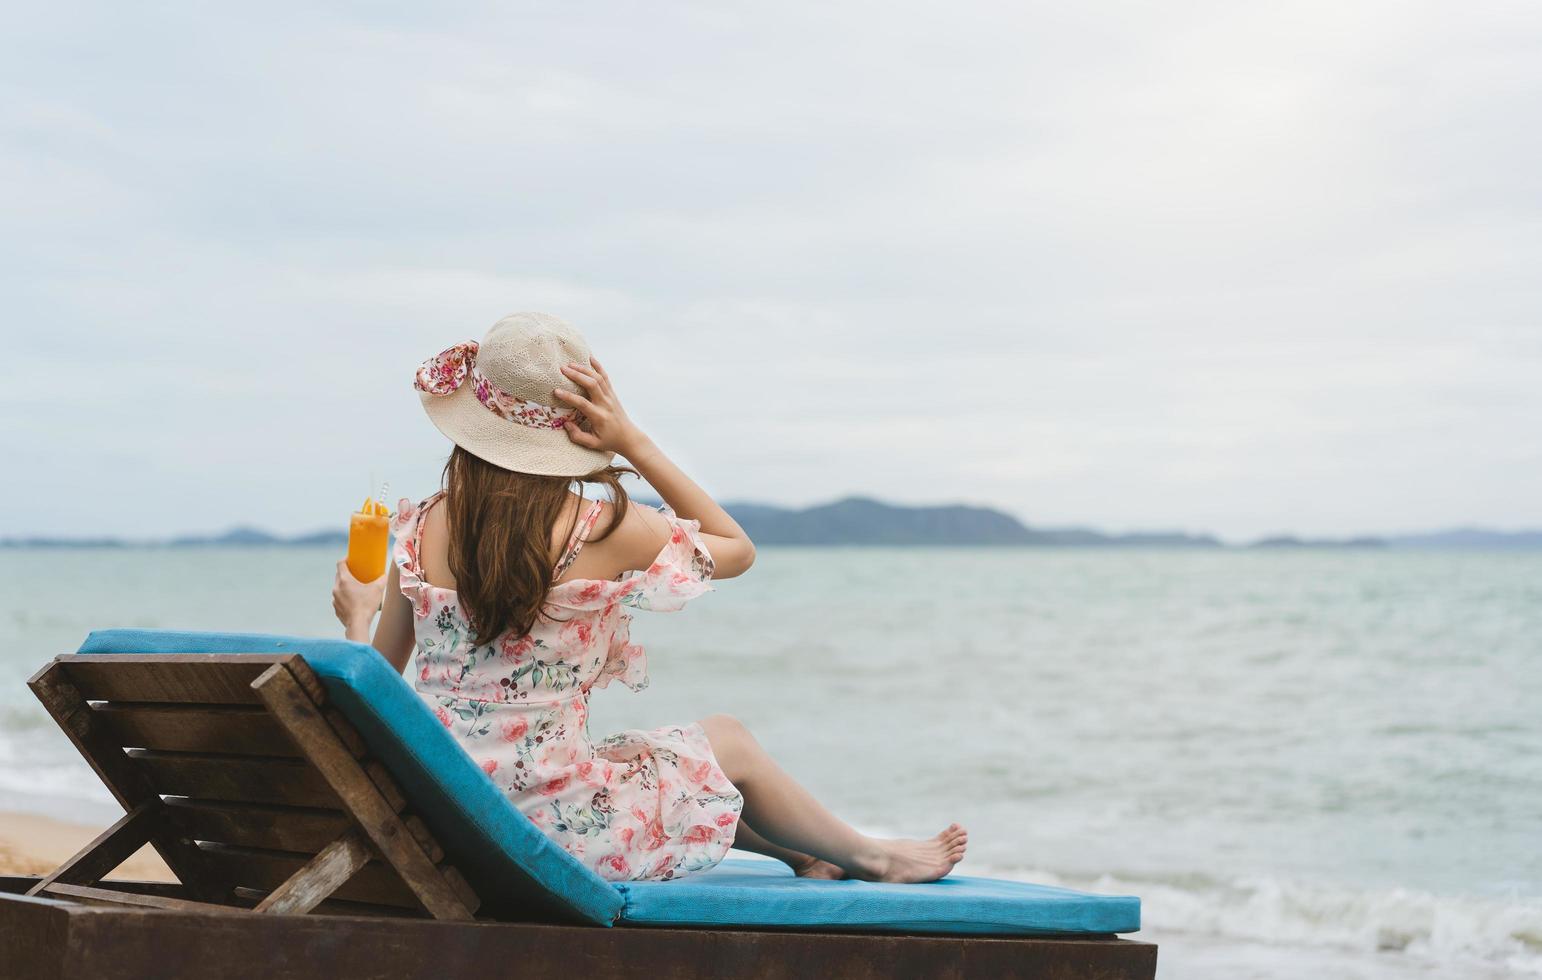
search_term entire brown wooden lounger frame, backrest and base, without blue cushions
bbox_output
[0,653,1157,980]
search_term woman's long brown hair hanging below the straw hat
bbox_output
[444,445,635,646]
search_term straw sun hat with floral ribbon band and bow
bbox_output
[413,313,612,476]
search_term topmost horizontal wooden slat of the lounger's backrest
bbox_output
[59,653,295,704]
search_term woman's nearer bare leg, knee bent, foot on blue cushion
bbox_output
[702,715,968,881]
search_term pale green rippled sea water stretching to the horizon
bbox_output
[0,549,1542,978]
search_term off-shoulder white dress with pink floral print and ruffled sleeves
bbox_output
[393,493,743,881]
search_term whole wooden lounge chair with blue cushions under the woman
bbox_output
[0,630,1157,980]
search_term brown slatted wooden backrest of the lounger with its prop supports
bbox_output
[26,653,480,921]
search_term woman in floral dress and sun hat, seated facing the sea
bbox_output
[333,313,968,881]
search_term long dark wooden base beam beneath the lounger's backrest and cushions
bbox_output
[0,878,1157,980]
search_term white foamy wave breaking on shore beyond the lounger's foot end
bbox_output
[971,868,1542,977]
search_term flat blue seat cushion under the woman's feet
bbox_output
[615,860,1141,935]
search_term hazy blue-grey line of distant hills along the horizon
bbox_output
[0,496,1542,550]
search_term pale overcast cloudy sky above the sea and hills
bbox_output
[0,0,1542,539]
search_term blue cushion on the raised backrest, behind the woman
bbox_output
[80,630,621,926]
